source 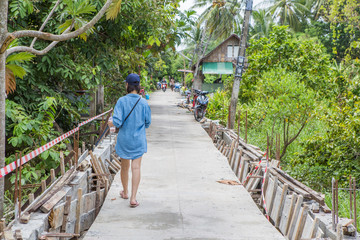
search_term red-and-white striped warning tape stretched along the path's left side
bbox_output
[0,109,112,178]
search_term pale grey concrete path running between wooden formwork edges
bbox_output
[85,91,284,240]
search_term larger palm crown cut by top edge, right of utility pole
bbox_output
[269,0,310,31]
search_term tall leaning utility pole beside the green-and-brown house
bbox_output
[228,0,253,129]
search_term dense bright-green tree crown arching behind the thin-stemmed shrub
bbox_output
[240,26,332,101]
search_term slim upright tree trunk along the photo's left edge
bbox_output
[0,0,8,218]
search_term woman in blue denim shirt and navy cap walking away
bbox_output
[109,73,151,207]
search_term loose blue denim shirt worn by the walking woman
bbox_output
[113,94,151,159]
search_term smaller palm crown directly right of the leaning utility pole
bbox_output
[250,9,274,38]
